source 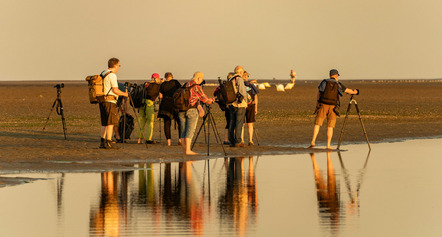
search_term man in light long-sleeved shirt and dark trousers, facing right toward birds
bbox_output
[228,66,247,147]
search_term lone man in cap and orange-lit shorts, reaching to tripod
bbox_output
[308,69,359,149]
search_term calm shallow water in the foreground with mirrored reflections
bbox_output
[0,139,442,236]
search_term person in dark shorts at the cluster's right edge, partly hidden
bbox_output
[241,71,259,146]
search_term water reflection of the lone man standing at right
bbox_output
[310,151,340,229]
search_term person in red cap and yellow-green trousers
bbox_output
[138,73,161,144]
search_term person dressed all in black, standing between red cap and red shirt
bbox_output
[158,72,181,146]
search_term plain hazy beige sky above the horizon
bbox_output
[0,0,442,81]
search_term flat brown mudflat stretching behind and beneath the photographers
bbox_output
[0,80,442,170]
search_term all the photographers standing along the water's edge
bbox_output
[99,58,359,155]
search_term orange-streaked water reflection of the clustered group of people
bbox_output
[86,157,258,236]
